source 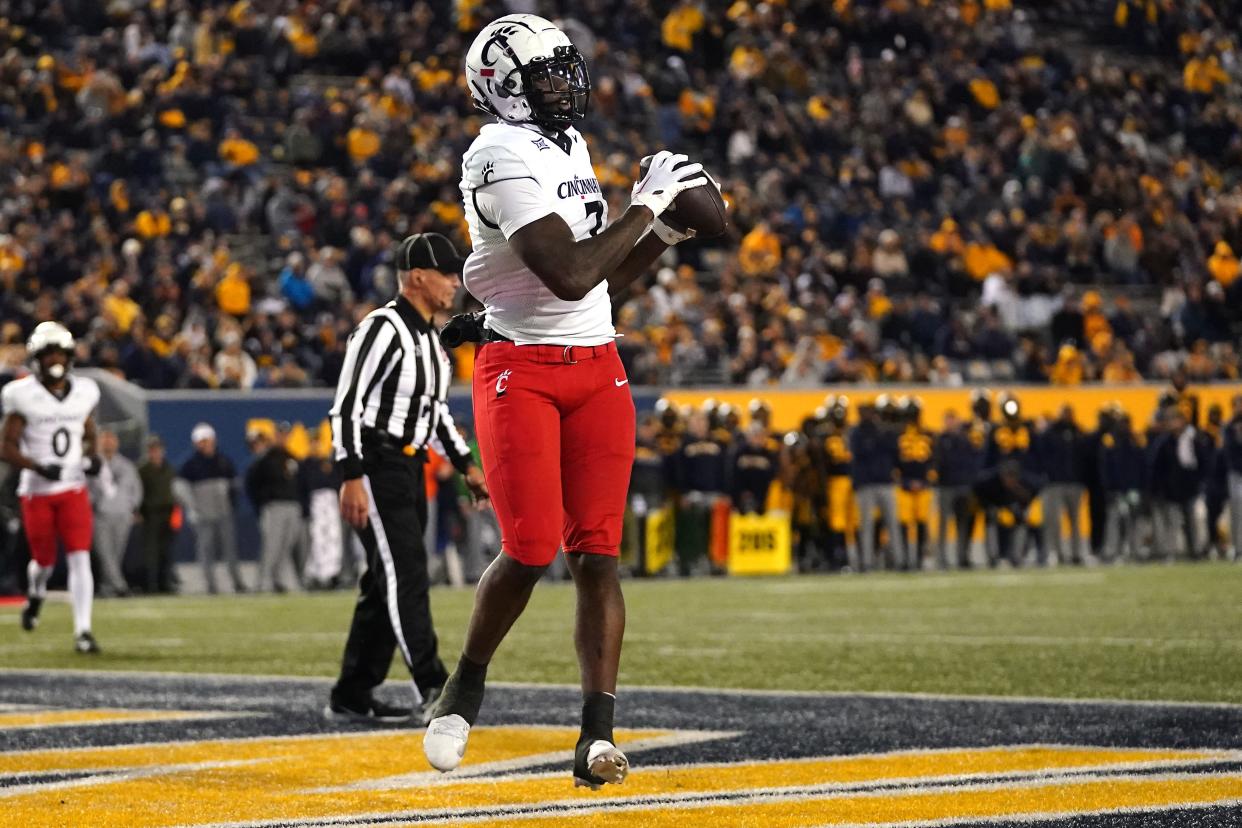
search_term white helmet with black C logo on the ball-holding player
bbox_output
[466,15,591,129]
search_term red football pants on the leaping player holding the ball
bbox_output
[474,343,635,566]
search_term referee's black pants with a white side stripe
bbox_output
[332,449,448,708]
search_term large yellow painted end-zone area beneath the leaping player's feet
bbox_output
[0,711,1242,828]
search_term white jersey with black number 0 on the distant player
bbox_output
[0,375,99,495]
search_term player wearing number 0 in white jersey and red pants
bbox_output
[0,322,99,653]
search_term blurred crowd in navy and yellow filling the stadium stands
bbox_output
[0,0,1242,389]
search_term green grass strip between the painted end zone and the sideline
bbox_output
[0,564,1242,703]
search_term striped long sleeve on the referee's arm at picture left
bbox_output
[328,317,400,480]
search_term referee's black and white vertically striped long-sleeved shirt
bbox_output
[329,297,472,480]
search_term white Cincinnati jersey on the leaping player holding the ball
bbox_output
[461,123,616,345]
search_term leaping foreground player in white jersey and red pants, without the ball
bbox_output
[424,15,708,788]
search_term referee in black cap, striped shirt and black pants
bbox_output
[324,233,487,722]
